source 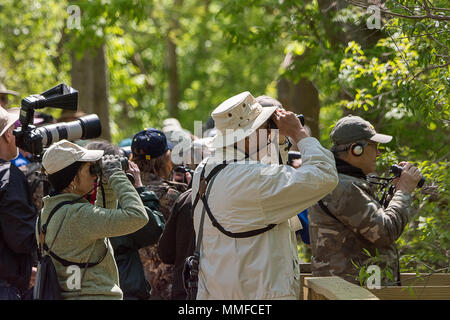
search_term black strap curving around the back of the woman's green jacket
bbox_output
[38,199,108,268]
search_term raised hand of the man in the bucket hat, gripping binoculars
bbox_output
[272,109,309,143]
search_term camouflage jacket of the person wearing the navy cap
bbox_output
[139,174,187,300]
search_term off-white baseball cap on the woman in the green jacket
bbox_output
[42,140,104,175]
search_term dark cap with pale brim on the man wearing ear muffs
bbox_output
[330,115,392,145]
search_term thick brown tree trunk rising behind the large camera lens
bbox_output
[69,45,111,141]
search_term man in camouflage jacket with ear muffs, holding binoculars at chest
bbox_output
[309,115,421,285]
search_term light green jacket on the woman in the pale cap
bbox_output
[36,171,148,300]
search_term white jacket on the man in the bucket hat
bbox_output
[192,137,338,300]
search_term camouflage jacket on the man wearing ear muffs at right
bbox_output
[309,165,411,285]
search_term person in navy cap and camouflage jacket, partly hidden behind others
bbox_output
[131,128,187,300]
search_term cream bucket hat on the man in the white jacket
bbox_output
[211,91,278,148]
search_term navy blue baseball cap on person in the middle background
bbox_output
[131,128,173,160]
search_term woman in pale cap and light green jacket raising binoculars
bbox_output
[36,140,148,299]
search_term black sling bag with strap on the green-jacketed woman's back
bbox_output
[33,198,108,300]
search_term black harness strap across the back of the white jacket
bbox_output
[193,163,276,238]
